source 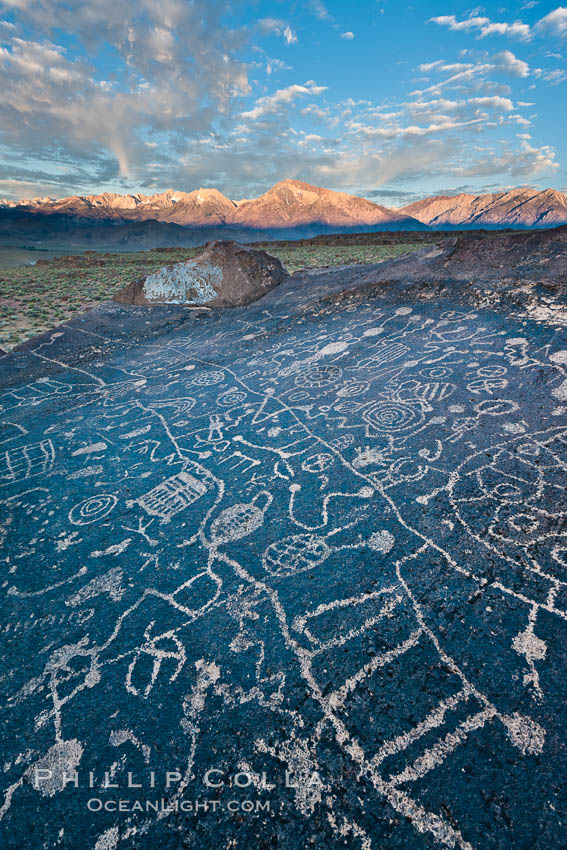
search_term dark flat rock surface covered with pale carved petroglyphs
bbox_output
[0,260,567,850]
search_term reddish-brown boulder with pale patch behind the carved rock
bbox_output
[113,242,287,307]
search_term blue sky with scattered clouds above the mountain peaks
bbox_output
[0,0,567,207]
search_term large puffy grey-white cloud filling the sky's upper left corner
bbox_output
[0,0,249,181]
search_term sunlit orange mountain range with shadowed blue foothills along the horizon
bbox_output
[0,180,567,250]
